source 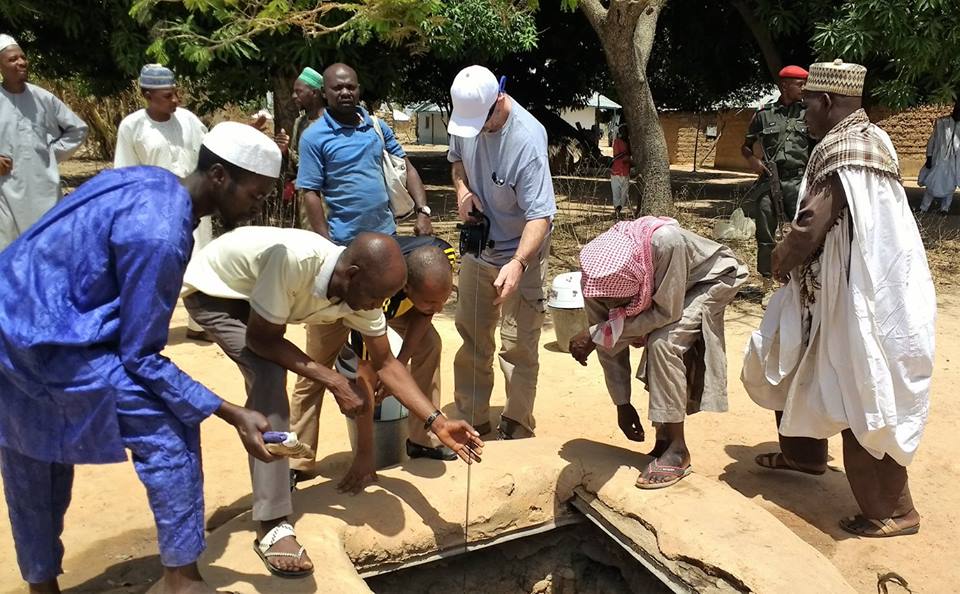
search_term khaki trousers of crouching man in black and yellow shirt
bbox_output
[290,316,442,470]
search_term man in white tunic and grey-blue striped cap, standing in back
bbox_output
[113,64,213,341]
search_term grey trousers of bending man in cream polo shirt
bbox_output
[183,293,293,522]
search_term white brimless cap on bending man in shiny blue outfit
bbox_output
[202,122,283,177]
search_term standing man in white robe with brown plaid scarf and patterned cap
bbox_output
[741,60,936,537]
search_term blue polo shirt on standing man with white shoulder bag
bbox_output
[297,107,406,245]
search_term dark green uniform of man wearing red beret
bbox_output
[744,101,814,277]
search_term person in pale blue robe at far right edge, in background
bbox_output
[917,98,960,214]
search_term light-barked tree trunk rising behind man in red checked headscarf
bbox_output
[580,0,674,215]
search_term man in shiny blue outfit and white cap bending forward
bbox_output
[0,122,281,594]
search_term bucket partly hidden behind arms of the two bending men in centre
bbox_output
[335,328,410,469]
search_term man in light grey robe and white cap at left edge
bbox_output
[0,35,87,250]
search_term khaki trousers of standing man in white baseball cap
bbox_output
[453,238,550,437]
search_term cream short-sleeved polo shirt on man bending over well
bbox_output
[181,227,387,336]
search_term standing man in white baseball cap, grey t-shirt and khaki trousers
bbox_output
[447,66,557,439]
